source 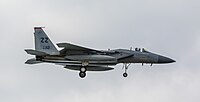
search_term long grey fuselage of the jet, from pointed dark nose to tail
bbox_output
[40,49,175,65]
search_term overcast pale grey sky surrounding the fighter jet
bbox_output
[0,0,200,102]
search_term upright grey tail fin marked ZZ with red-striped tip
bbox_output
[34,27,59,55]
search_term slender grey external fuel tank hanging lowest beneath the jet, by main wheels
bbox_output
[64,65,114,71]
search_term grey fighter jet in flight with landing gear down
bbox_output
[25,27,175,78]
